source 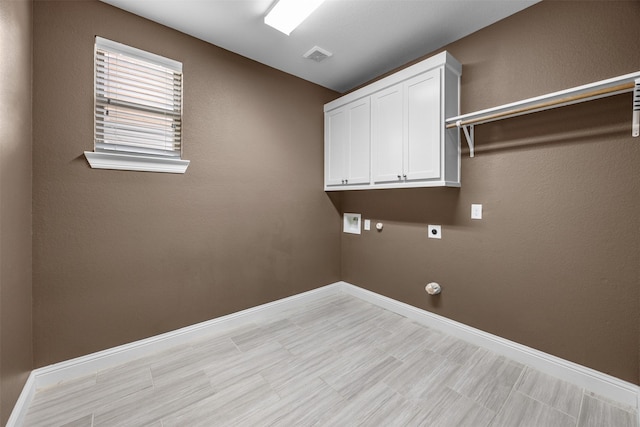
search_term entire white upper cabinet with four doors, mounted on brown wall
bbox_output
[325,52,461,190]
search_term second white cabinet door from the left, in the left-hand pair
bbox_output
[346,97,371,184]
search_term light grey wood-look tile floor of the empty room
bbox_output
[25,294,637,427]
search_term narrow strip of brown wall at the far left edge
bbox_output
[0,0,33,425]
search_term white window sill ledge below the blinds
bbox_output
[84,151,190,173]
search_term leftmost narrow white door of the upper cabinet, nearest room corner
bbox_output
[324,108,349,185]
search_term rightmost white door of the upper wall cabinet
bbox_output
[403,69,443,180]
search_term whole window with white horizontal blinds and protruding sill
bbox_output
[85,37,189,173]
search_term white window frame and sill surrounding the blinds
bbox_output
[84,36,190,173]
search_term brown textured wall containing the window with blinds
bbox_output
[33,1,340,367]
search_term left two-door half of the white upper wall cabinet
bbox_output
[324,98,371,186]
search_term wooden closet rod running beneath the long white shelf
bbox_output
[447,82,635,129]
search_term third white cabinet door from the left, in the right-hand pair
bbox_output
[371,84,403,182]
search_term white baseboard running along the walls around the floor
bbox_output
[7,282,640,427]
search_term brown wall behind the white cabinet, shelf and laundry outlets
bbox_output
[342,1,640,383]
